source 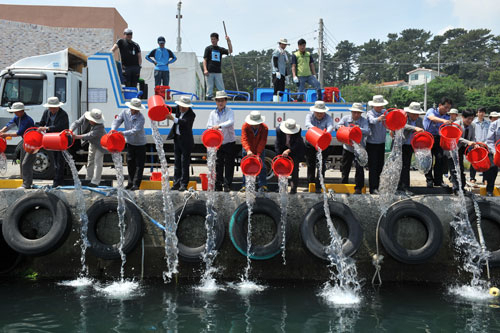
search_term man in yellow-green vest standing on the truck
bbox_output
[292,38,323,100]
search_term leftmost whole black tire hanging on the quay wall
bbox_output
[2,192,71,256]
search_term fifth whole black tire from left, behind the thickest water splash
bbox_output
[300,201,363,260]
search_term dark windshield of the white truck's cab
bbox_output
[2,78,43,106]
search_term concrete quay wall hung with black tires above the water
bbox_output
[0,190,500,283]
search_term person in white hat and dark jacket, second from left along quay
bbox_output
[37,97,69,187]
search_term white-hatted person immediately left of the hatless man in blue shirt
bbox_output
[398,102,425,194]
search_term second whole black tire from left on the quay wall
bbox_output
[87,197,143,260]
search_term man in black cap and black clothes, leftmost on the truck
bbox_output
[111,28,142,88]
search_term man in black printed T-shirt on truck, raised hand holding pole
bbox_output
[203,32,233,99]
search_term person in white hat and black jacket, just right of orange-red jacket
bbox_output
[274,118,305,194]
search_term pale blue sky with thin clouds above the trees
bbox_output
[2,0,500,57]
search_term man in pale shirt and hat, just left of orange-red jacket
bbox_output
[207,91,236,192]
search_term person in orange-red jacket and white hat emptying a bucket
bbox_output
[241,111,268,192]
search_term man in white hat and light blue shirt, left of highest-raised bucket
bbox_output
[111,98,146,191]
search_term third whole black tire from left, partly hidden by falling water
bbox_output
[175,200,226,262]
